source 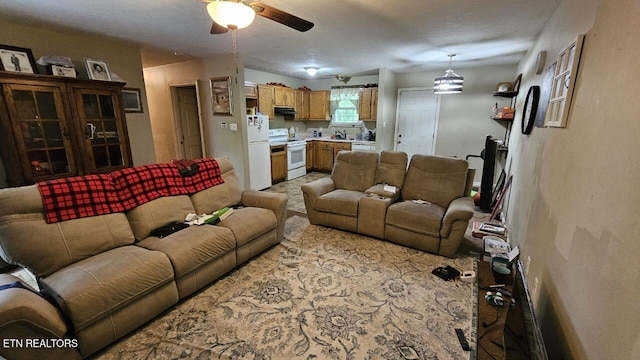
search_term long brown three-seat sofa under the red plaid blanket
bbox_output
[0,158,287,359]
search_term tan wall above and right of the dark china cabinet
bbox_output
[0,19,156,173]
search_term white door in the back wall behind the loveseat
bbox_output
[395,89,440,160]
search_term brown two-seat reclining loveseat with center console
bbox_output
[302,151,475,257]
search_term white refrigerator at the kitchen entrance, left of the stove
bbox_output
[247,115,271,190]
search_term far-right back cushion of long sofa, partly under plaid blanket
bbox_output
[191,158,242,214]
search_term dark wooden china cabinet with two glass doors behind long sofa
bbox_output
[0,73,131,186]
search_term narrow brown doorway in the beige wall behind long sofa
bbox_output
[171,85,205,159]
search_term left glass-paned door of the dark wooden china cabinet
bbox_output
[4,84,76,182]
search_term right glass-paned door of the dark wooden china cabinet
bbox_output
[76,89,128,172]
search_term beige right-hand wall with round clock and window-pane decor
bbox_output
[507,0,640,359]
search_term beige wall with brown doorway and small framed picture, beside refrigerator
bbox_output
[144,55,248,185]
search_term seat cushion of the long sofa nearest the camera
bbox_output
[40,245,177,331]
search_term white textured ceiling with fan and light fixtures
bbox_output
[0,0,561,78]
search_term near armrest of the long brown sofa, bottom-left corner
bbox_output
[0,274,81,359]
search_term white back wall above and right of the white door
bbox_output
[394,62,518,182]
